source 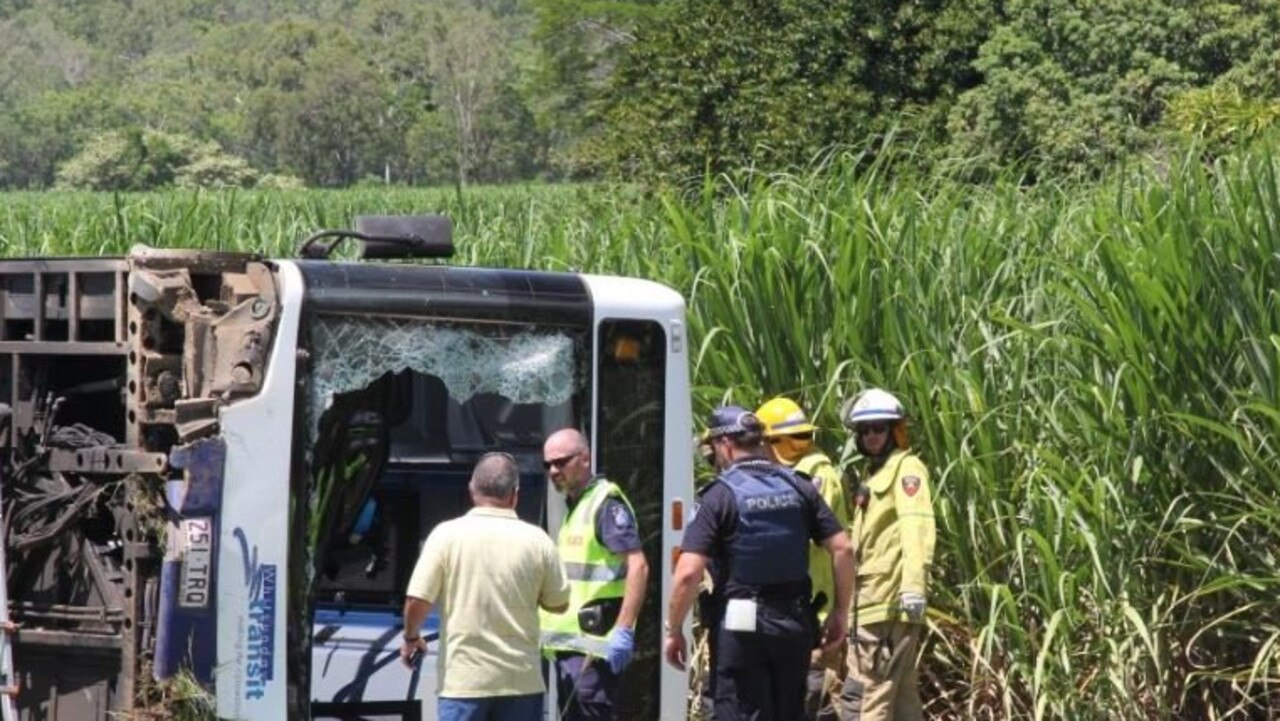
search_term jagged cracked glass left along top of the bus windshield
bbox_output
[308,315,580,442]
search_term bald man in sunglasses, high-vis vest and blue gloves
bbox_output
[541,428,649,721]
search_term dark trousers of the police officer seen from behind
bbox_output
[713,603,815,721]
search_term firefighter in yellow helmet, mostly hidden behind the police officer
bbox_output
[755,397,850,721]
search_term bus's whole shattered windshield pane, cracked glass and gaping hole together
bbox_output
[307,315,588,595]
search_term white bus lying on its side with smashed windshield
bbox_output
[0,216,692,721]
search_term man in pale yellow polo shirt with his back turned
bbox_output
[401,453,568,721]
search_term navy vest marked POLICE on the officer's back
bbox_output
[721,465,809,585]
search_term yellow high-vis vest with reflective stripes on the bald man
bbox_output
[540,478,635,656]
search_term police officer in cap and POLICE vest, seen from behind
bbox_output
[663,406,854,721]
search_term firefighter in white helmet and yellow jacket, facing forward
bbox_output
[838,388,936,721]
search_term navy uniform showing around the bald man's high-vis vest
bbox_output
[554,475,640,721]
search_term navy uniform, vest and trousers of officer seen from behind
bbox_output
[681,458,844,721]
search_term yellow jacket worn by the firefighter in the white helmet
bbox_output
[852,450,936,626]
